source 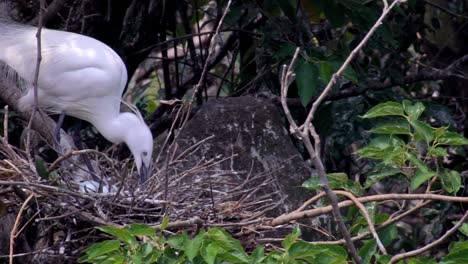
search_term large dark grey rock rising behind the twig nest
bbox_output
[170,97,311,214]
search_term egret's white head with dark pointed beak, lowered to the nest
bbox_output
[124,113,153,183]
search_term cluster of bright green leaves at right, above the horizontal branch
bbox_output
[356,100,468,193]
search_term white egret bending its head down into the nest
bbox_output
[0,12,153,181]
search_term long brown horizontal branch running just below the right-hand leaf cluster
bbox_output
[270,193,468,226]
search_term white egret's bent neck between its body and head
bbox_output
[92,114,129,143]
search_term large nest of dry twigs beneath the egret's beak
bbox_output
[0,116,283,263]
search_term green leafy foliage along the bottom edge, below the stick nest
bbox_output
[79,224,348,264]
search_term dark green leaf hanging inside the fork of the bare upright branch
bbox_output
[296,59,319,106]
